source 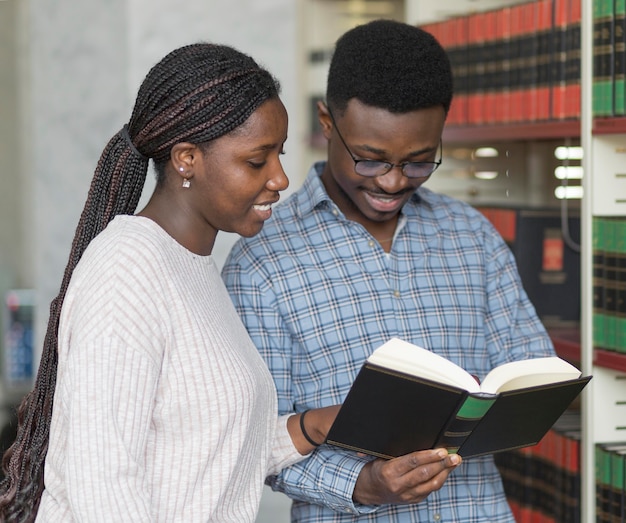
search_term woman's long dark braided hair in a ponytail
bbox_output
[0,43,279,522]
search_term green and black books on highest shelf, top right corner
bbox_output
[592,0,626,117]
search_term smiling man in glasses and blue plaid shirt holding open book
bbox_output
[223,20,554,523]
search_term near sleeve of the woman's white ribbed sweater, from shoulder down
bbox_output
[56,235,166,522]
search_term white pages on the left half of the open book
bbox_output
[367,338,480,392]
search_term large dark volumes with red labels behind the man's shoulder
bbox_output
[478,205,580,328]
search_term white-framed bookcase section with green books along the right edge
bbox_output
[581,0,626,522]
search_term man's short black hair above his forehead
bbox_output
[326,20,452,113]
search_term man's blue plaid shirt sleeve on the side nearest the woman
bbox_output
[222,262,377,514]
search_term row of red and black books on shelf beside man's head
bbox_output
[421,0,581,125]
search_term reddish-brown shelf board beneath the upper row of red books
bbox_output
[443,120,580,144]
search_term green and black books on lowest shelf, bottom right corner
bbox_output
[595,442,626,523]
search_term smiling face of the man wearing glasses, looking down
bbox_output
[318,99,445,234]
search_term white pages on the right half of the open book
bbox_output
[480,356,581,393]
